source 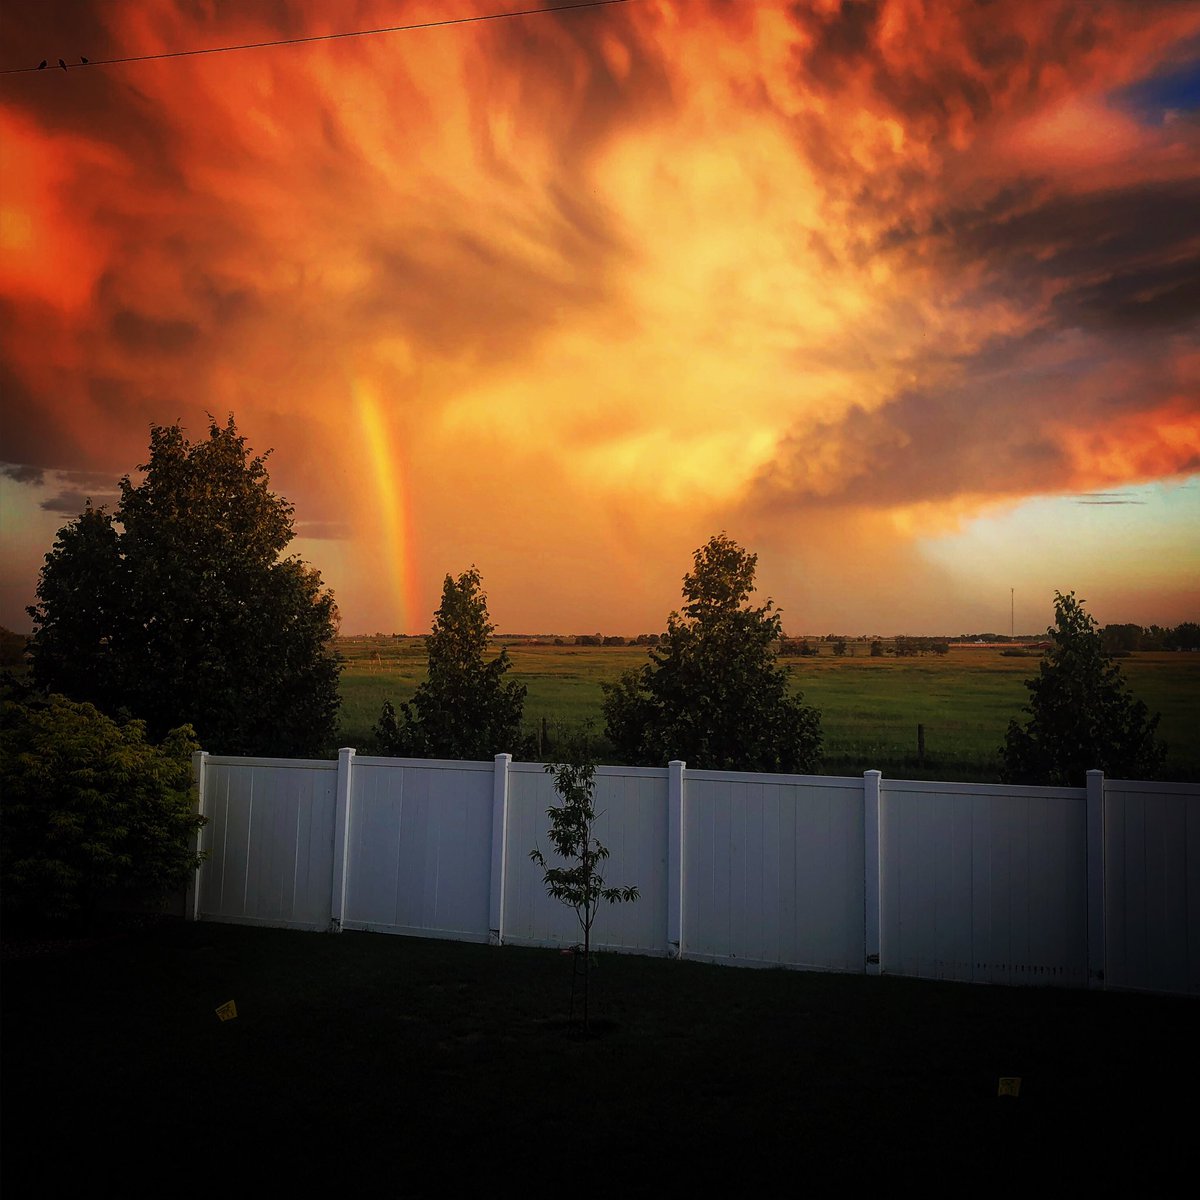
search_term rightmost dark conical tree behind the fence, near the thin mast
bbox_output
[1000,592,1166,787]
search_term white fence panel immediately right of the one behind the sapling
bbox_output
[683,770,865,971]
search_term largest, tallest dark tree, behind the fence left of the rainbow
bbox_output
[29,416,340,755]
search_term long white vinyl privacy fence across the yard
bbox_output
[188,749,1200,995]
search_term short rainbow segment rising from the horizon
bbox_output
[352,379,418,634]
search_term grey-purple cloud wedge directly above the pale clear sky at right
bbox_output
[751,329,1200,511]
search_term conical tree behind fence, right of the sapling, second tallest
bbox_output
[604,534,822,773]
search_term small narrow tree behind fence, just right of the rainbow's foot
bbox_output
[374,566,532,760]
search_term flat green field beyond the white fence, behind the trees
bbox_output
[340,637,1200,782]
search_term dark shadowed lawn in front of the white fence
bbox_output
[2,923,1196,1195]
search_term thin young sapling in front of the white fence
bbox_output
[529,744,638,1033]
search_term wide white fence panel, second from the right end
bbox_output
[881,780,1087,986]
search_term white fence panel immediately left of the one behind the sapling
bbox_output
[343,757,493,941]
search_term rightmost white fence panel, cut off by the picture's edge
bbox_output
[1104,780,1200,995]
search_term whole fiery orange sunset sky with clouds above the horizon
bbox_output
[0,0,1200,635]
